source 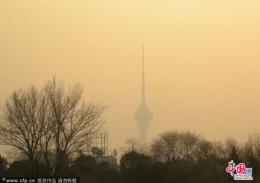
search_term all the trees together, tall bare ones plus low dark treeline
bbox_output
[0,77,260,183]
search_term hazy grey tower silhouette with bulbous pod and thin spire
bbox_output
[134,45,153,144]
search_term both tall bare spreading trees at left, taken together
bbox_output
[0,78,107,176]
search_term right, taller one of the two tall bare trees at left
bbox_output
[40,78,106,175]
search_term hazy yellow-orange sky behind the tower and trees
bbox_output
[0,0,260,156]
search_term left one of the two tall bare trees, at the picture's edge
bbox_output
[0,86,45,176]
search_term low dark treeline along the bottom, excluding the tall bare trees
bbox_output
[0,131,260,183]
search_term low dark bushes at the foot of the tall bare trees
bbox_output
[0,155,118,183]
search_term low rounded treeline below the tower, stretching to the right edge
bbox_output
[119,131,260,183]
